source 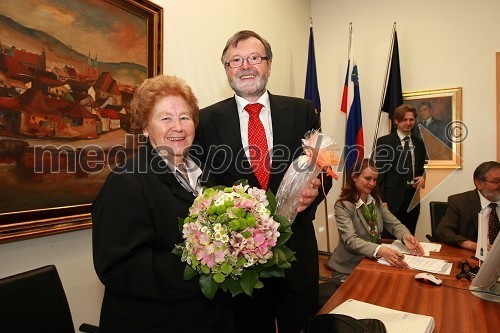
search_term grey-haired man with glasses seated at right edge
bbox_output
[435,161,500,251]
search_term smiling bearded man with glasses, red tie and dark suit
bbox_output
[193,31,331,333]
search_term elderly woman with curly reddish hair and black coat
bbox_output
[92,76,233,333]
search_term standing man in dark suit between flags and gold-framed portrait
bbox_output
[375,104,427,233]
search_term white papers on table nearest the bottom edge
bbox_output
[330,299,436,333]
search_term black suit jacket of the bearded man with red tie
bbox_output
[193,94,331,292]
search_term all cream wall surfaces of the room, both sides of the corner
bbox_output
[0,0,500,326]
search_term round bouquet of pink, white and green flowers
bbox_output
[172,180,295,299]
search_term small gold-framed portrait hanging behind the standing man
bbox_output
[403,87,468,168]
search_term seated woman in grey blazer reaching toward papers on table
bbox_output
[327,159,424,281]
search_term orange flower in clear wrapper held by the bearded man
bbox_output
[276,130,339,223]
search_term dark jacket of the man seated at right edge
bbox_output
[436,190,481,247]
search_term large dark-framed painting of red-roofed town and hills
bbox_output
[0,0,163,243]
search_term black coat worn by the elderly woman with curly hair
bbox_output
[92,145,231,333]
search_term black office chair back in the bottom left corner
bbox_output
[0,265,99,333]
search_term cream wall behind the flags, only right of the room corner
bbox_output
[311,0,500,246]
